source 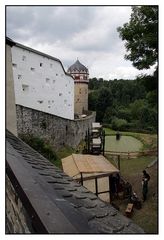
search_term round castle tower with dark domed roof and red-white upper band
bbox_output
[67,60,89,114]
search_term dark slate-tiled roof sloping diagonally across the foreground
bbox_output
[6,131,144,234]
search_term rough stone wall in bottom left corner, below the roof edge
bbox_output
[6,176,34,233]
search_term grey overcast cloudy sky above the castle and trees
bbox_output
[6,6,155,80]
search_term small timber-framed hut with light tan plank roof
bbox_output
[61,154,119,201]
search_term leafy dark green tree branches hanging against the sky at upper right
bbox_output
[117,6,158,69]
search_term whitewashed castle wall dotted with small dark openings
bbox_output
[12,44,74,119]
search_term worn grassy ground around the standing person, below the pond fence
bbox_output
[106,155,158,234]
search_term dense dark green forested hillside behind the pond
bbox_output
[89,74,158,133]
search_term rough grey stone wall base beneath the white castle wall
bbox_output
[16,105,95,149]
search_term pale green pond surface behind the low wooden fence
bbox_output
[105,136,143,152]
